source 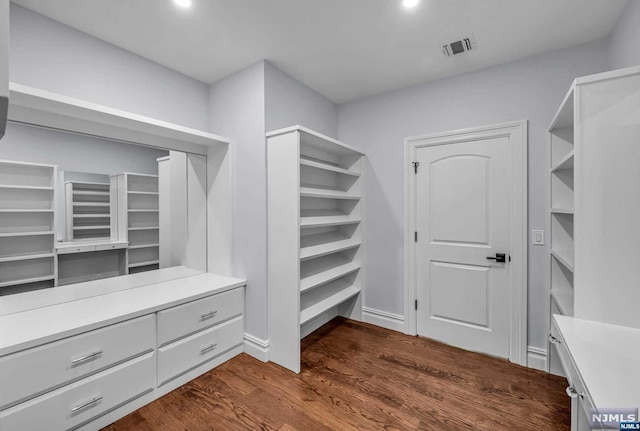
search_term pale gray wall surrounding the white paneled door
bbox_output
[339,41,608,347]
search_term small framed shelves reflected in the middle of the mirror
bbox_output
[64,181,113,241]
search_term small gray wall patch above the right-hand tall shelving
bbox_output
[609,0,640,69]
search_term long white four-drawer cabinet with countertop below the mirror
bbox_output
[0,268,245,431]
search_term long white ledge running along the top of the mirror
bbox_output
[8,82,229,155]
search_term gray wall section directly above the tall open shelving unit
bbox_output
[265,61,338,138]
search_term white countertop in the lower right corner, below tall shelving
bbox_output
[553,315,640,408]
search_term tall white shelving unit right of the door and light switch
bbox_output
[547,67,640,374]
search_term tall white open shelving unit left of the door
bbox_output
[267,126,363,373]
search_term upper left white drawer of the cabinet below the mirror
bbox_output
[0,315,156,409]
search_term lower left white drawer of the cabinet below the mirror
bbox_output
[0,352,155,431]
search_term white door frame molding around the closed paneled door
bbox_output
[404,120,528,366]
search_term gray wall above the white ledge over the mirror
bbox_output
[9,3,209,130]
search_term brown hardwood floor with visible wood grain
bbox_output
[105,319,570,431]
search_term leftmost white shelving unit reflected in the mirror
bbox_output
[0,160,57,295]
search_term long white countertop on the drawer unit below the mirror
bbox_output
[0,268,246,356]
